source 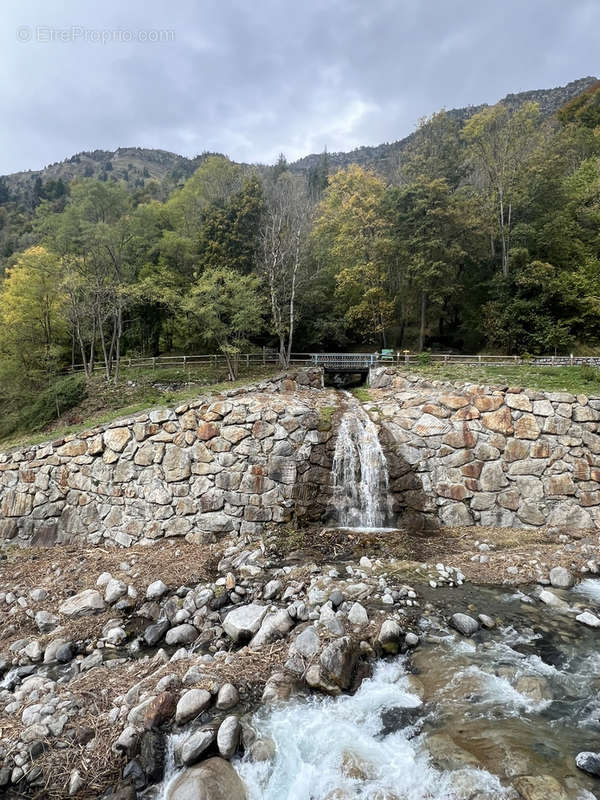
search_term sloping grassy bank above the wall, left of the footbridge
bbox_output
[0,366,277,450]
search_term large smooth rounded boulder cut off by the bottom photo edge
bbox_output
[167,758,247,800]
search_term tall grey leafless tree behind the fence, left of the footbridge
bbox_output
[260,171,312,368]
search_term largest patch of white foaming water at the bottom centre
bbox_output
[235,661,508,800]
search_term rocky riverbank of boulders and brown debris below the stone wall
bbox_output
[0,528,600,800]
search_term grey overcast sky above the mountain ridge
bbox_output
[0,0,600,174]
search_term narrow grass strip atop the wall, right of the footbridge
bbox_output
[410,364,600,396]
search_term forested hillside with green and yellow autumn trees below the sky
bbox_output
[0,79,600,438]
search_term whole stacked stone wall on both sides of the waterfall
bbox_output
[0,368,600,546]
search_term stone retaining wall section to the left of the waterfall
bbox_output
[0,369,332,546]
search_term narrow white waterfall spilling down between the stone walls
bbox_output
[332,394,392,528]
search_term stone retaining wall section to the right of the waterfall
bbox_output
[368,368,600,528]
